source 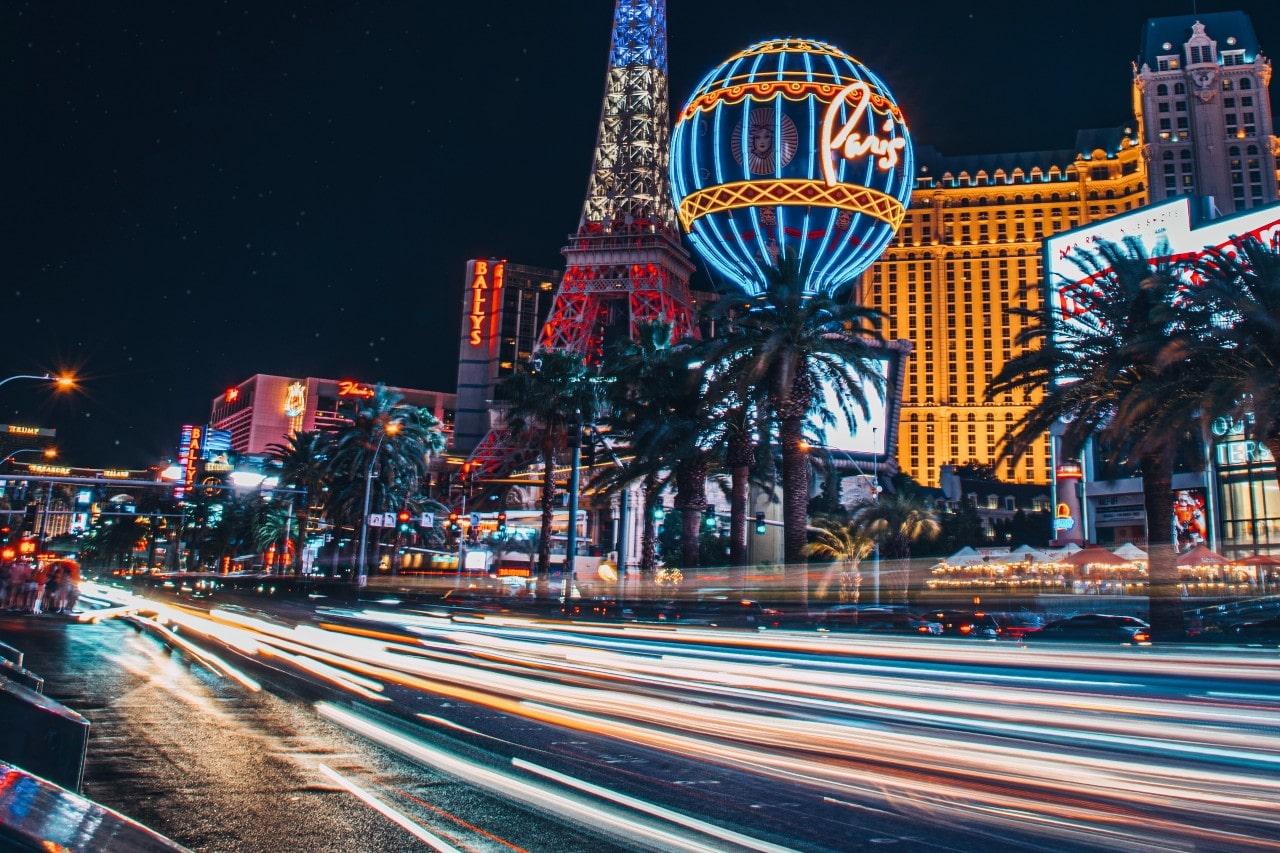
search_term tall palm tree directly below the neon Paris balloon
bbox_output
[708,257,882,599]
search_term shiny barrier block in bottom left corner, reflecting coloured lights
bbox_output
[0,762,186,853]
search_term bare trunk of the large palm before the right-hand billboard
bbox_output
[1142,453,1185,642]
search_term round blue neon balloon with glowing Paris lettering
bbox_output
[671,38,915,293]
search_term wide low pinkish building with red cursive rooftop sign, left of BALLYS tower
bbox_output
[209,373,457,453]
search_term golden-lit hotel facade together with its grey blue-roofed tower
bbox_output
[859,13,1277,487]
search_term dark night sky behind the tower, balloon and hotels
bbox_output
[0,0,1280,466]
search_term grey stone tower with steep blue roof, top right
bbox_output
[1133,12,1276,214]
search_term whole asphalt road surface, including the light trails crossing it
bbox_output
[0,584,1280,850]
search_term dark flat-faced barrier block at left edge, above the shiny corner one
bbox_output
[0,679,88,792]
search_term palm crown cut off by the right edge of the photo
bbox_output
[1166,237,1280,491]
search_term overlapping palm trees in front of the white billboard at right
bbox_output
[987,240,1280,638]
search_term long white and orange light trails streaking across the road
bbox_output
[85,581,1280,849]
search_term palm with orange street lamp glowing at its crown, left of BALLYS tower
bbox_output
[325,384,445,571]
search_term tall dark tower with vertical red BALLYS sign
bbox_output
[453,259,561,455]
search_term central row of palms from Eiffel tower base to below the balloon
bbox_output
[498,252,882,604]
